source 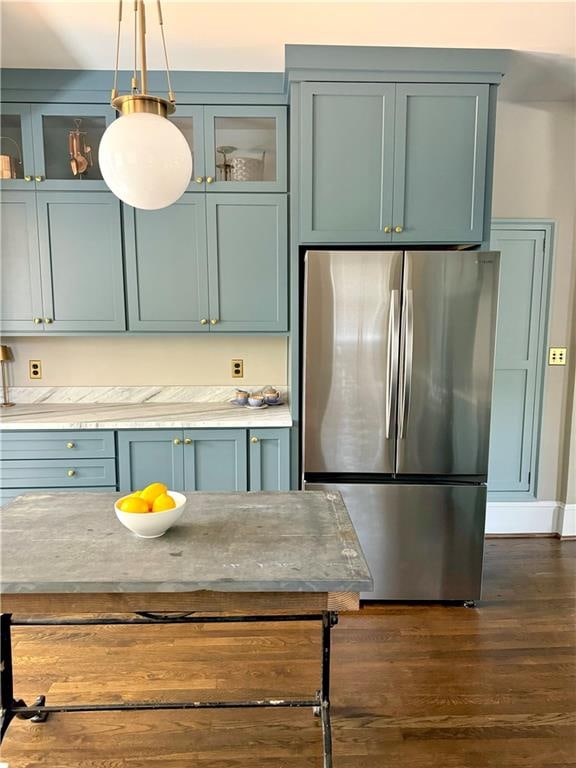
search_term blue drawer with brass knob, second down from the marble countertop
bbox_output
[0,457,116,489]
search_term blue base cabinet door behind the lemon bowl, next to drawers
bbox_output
[118,429,184,492]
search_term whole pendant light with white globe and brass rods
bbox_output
[98,0,192,210]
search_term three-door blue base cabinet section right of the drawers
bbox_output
[118,429,290,491]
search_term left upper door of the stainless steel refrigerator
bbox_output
[304,251,402,473]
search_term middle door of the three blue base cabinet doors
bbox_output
[183,429,248,491]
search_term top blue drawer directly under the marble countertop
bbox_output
[2,430,116,461]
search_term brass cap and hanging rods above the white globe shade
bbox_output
[110,0,176,117]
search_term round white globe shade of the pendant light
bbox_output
[98,112,192,210]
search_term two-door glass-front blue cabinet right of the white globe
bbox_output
[170,106,287,192]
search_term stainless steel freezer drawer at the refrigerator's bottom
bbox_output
[305,483,486,600]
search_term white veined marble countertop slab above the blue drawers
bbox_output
[0,402,292,430]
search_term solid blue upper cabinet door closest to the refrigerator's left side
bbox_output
[206,194,288,332]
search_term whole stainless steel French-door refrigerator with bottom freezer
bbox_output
[302,250,499,601]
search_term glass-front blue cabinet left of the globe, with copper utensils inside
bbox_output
[1,104,115,191]
